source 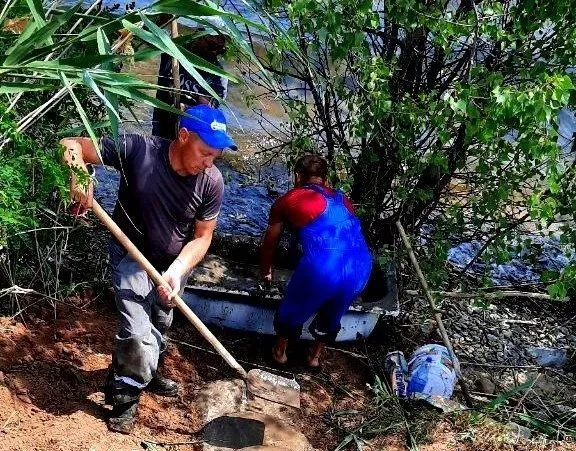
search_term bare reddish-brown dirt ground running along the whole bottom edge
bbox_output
[0,294,576,451]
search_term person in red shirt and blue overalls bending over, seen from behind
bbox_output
[260,155,372,367]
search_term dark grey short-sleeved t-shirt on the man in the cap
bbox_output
[101,134,224,270]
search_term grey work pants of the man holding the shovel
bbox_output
[110,239,188,390]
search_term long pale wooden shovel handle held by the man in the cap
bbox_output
[92,200,247,378]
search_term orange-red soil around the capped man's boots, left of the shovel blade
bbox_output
[0,299,206,451]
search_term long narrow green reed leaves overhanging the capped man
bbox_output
[0,0,259,141]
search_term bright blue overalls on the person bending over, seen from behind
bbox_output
[275,184,372,343]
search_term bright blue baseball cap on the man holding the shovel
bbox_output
[180,105,238,150]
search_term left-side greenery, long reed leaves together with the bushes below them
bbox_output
[0,0,263,297]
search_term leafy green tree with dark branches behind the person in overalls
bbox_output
[254,0,576,295]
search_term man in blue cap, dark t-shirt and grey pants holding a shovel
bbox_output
[60,105,236,433]
